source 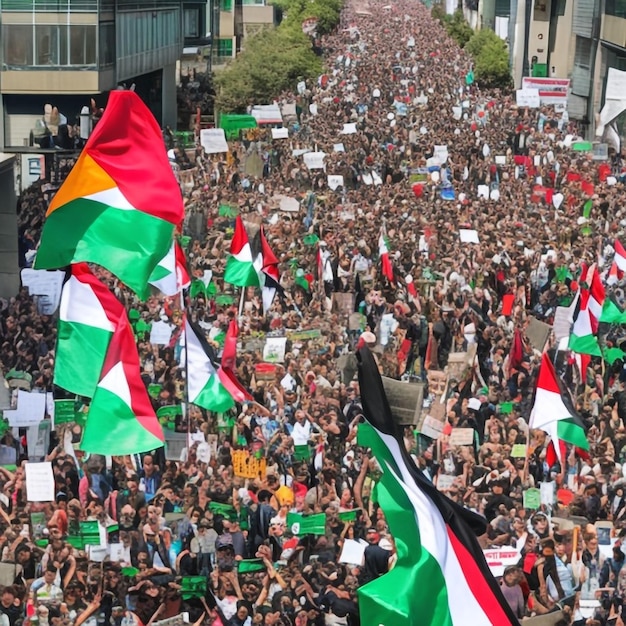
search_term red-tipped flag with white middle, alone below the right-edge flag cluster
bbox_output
[529,353,589,463]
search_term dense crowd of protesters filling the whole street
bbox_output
[0,0,626,626]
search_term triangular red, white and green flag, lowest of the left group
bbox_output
[80,315,165,455]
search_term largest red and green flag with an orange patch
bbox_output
[35,91,184,298]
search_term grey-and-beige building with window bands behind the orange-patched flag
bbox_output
[0,0,183,152]
